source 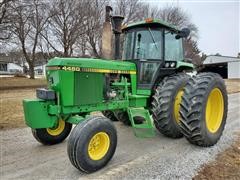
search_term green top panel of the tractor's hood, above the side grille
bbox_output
[47,57,136,71]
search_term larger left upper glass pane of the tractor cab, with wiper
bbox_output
[123,28,162,60]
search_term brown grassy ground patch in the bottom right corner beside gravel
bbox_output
[193,135,240,180]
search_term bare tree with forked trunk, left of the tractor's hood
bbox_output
[11,0,49,79]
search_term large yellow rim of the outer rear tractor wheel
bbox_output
[205,88,224,133]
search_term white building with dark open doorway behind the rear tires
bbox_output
[203,55,240,79]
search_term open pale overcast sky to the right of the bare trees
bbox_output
[147,0,240,56]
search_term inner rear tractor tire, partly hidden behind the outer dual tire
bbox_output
[151,73,189,138]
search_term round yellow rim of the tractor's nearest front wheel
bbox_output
[88,132,110,160]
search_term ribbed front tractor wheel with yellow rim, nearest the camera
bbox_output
[67,116,117,173]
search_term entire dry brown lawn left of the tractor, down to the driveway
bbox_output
[0,77,46,129]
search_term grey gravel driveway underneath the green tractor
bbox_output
[0,93,240,180]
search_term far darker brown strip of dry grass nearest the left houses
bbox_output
[0,77,46,90]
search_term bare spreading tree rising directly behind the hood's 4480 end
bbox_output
[41,0,88,57]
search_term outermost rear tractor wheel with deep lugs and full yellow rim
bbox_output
[180,73,228,147]
